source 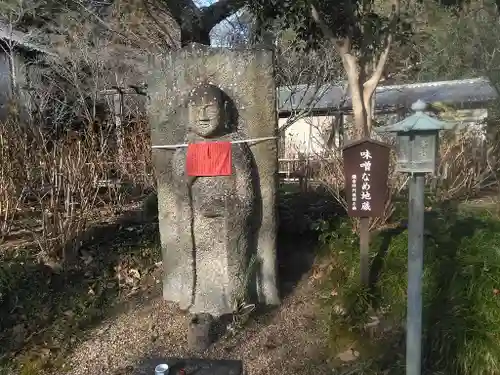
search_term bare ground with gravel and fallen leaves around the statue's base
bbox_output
[0,194,340,375]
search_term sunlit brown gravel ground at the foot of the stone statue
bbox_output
[59,275,328,375]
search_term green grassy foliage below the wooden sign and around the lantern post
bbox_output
[320,209,500,375]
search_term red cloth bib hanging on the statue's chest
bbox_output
[186,142,232,177]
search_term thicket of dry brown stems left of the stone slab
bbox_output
[0,116,154,263]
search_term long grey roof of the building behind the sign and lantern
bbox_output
[278,78,498,115]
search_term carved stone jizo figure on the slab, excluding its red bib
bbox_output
[170,84,258,317]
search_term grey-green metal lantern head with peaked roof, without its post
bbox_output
[375,100,447,174]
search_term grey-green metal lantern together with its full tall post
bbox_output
[375,100,454,375]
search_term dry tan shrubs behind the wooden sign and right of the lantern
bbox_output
[314,127,500,230]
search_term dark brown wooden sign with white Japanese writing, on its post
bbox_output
[343,138,390,286]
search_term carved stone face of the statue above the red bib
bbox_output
[188,86,224,137]
